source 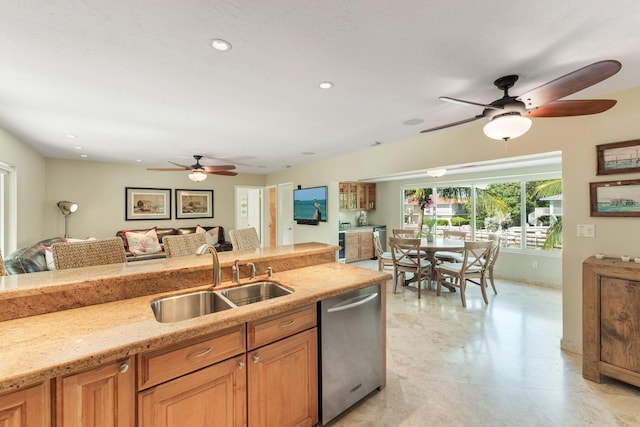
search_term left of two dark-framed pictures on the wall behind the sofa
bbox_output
[124,187,171,221]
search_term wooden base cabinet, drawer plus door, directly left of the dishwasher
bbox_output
[247,305,318,427]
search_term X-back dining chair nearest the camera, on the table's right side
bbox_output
[436,241,493,307]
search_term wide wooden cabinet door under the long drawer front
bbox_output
[138,354,247,427]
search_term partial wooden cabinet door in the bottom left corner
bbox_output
[0,381,51,427]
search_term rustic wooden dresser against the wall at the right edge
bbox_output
[582,257,640,387]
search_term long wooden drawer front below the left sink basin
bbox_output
[138,324,245,390]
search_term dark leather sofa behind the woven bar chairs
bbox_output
[4,226,233,274]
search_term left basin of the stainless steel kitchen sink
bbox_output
[151,290,233,323]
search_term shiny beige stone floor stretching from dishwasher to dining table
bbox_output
[332,262,640,427]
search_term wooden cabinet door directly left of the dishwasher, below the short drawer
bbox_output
[247,328,318,427]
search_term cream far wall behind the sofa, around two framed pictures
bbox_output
[45,159,265,243]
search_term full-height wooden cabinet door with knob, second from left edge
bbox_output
[57,357,136,427]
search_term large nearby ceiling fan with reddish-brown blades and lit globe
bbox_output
[421,60,622,141]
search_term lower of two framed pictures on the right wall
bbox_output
[589,179,640,216]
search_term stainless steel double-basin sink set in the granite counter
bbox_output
[151,281,292,323]
